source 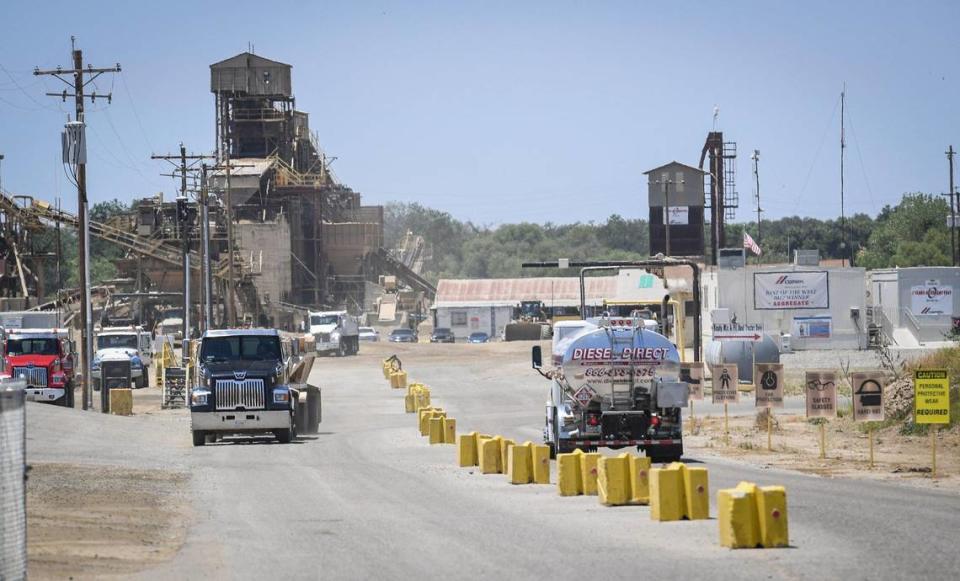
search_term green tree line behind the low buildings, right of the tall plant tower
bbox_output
[384,193,951,281]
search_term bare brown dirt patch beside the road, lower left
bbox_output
[27,463,190,579]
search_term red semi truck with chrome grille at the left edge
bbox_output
[3,329,75,407]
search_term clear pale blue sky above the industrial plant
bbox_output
[0,0,960,224]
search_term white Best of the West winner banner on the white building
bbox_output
[753,272,830,310]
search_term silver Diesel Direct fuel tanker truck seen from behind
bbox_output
[532,318,689,462]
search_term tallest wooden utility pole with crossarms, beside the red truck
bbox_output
[33,37,120,412]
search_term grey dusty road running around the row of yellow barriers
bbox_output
[29,344,960,580]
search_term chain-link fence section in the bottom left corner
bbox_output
[0,379,27,581]
